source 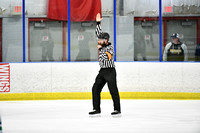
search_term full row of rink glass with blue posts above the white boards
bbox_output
[0,0,200,62]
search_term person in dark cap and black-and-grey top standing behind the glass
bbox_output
[163,33,188,61]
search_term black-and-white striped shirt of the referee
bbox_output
[96,22,115,68]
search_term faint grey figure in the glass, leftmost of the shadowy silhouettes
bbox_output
[40,27,54,61]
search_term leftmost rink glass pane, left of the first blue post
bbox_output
[0,0,23,62]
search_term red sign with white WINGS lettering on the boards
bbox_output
[0,63,10,92]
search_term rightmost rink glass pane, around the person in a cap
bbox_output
[162,0,200,61]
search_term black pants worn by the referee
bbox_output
[92,68,121,111]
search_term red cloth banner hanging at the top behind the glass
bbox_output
[48,0,101,21]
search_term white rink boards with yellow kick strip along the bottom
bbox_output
[0,62,200,100]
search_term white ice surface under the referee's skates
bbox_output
[0,100,200,133]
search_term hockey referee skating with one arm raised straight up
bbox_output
[89,13,121,115]
